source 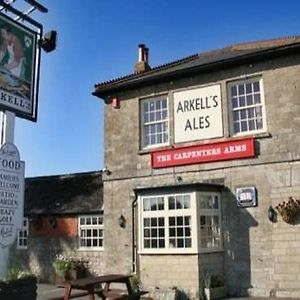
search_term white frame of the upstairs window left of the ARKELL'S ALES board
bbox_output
[140,95,170,149]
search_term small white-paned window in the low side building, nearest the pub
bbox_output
[78,215,103,250]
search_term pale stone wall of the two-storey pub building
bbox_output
[103,55,300,297]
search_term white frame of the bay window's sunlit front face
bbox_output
[138,191,198,254]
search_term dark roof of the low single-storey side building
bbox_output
[24,171,103,216]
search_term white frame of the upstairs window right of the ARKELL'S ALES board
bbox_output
[227,77,267,136]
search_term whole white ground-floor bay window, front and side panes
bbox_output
[139,191,221,253]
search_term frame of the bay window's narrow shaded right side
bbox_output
[197,192,223,252]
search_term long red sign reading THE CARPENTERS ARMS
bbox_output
[152,138,255,169]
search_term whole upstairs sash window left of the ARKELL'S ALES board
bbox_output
[140,96,169,148]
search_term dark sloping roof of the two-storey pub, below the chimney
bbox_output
[93,36,300,99]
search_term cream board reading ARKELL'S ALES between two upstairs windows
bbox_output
[174,84,223,143]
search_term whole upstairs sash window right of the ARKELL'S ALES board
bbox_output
[228,78,266,135]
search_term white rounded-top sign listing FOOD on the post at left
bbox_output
[0,143,25,247]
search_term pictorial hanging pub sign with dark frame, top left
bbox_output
[0,14,40,121]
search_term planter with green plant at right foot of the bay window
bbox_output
[204,273,227,300]
